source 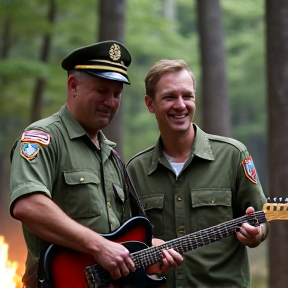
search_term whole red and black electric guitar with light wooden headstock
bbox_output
[39,198,288,288]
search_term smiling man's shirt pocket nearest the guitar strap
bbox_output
[140,194,164,238]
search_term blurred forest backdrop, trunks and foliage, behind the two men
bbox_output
[0,0,288,288]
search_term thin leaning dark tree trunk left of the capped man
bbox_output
[31,0,56,122]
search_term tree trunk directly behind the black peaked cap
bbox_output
[98,0,126,155]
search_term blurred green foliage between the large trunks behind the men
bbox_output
[0,0,287,288]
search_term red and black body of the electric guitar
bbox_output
[40,216,164,288]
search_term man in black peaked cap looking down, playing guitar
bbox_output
[10,41,183,288]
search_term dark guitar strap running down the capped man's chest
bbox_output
[112,149,147,218]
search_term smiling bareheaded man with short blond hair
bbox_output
[127,59,268,288]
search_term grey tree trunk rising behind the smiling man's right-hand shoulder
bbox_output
[197,0,231,136]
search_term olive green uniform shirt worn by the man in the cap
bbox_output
[10,106,130,288]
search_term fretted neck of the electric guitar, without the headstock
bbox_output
[131,211,267,269]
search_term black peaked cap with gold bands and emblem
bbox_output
[61,40,131,84]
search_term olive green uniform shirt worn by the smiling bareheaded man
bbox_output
[127,124,266,288]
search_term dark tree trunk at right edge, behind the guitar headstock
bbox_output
[266,0,288,288]
